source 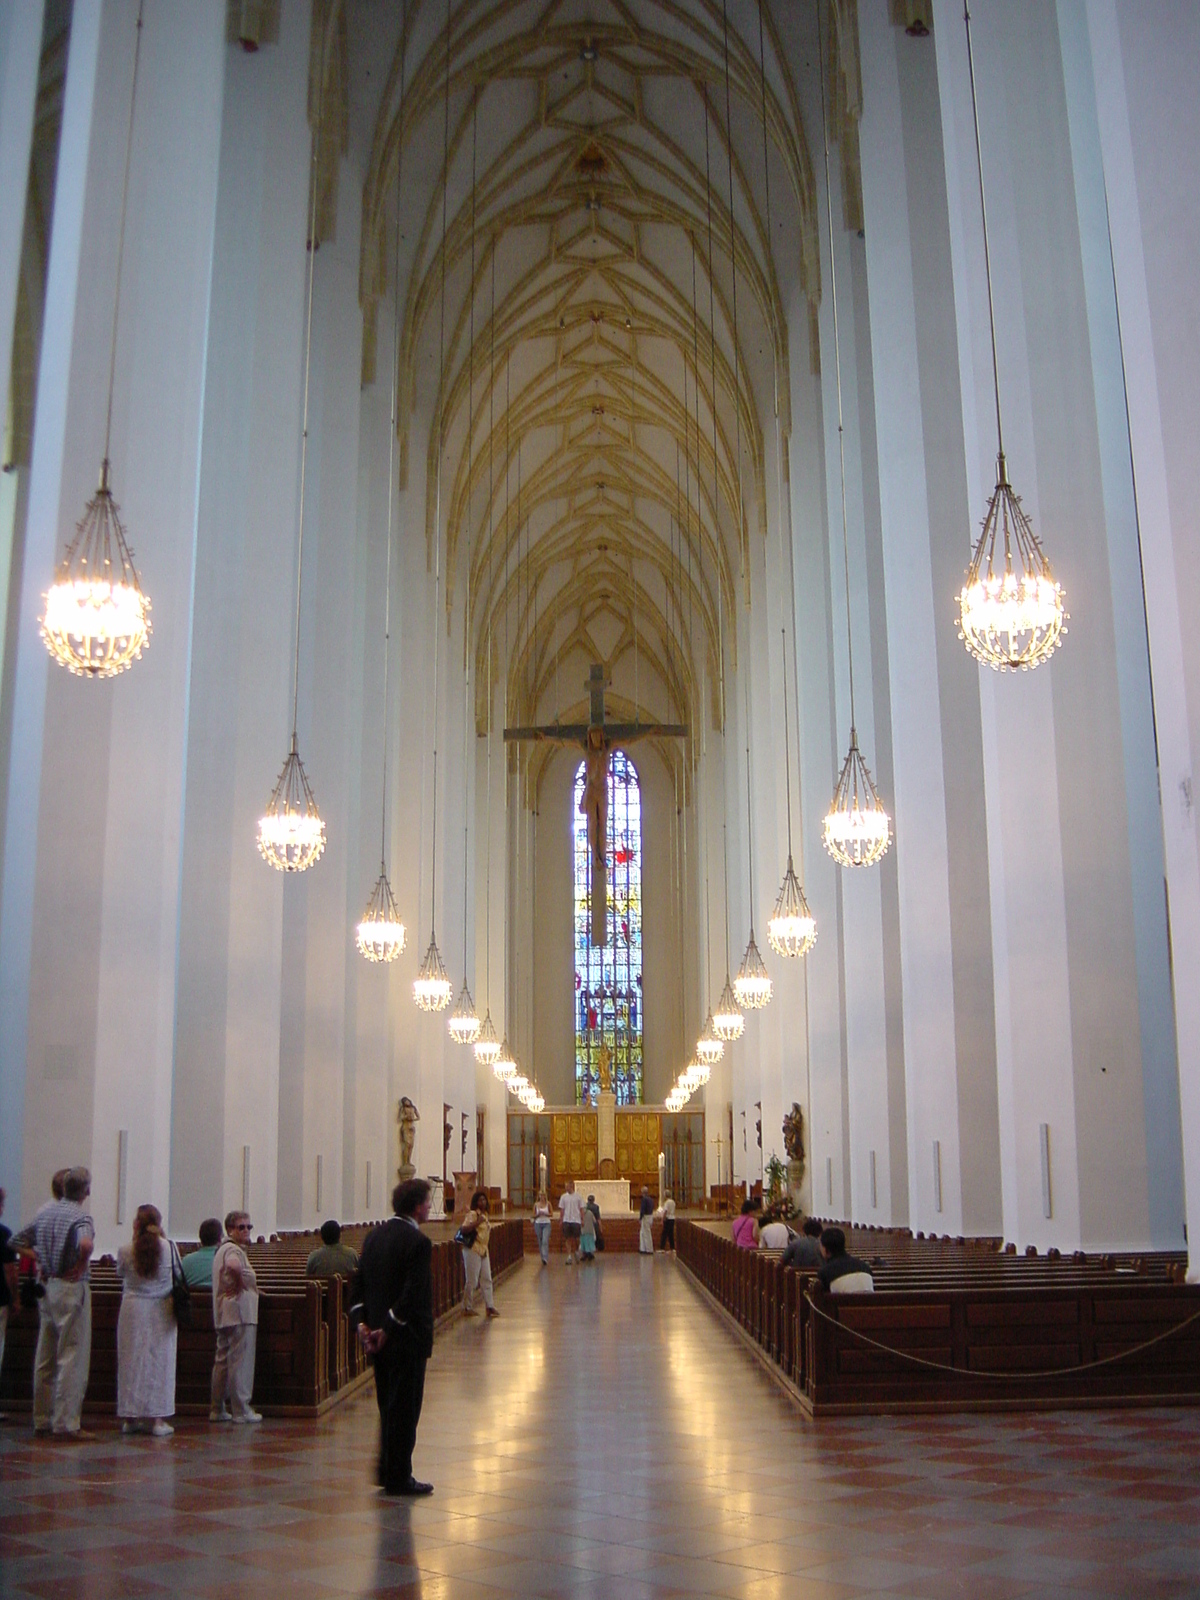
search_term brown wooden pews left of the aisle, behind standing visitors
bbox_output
[0,1222,522,1419]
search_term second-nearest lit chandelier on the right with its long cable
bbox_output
[816,8,891,867]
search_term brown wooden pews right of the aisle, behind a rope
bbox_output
[677,1221,1200,1416]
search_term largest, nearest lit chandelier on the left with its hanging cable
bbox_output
[38,5,150,678]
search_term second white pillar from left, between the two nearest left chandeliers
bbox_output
[170,0,312,1232]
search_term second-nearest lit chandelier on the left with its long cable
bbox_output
[258,21,325,872]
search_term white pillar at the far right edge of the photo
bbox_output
[1088,0,1200,1278]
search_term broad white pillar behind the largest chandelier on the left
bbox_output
[0,3,224,1248]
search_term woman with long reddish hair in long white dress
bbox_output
[117,1205,178,1438]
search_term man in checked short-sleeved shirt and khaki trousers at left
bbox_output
[34,1166,96,1440]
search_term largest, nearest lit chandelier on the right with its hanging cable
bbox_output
[958,5,1067,672]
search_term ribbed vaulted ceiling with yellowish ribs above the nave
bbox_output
[310,0,859,774]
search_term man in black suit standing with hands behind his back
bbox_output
[350,1178,434,1494]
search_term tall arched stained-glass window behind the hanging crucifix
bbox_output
[573,750,642,1106]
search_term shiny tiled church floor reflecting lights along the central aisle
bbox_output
[0,1256,1200,1600]
